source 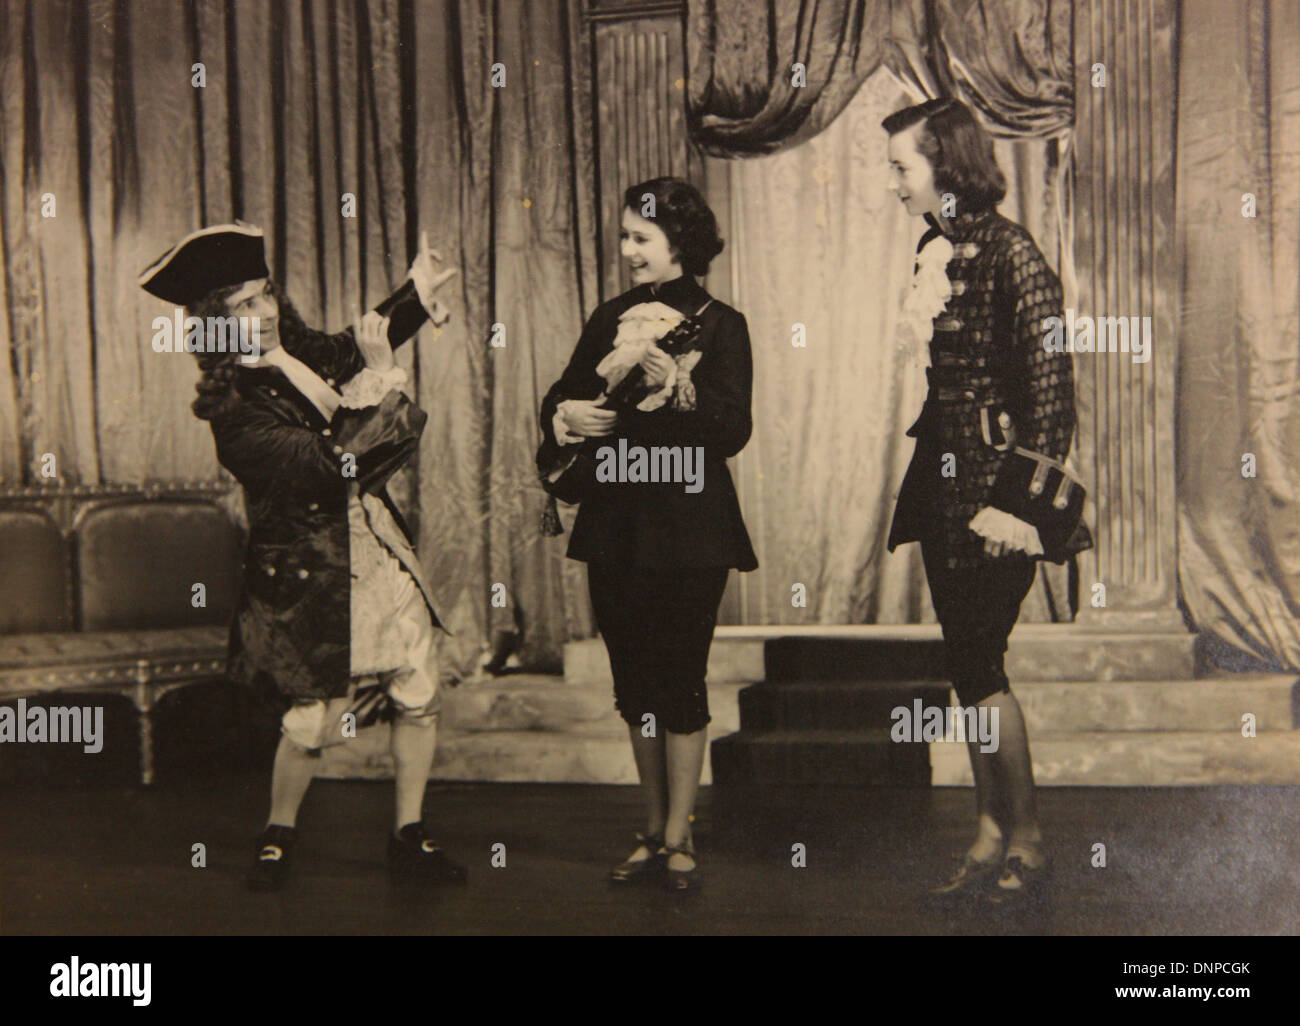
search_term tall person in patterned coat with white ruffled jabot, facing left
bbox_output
[884,99,1080,902]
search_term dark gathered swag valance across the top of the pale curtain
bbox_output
[686,0,1074,156]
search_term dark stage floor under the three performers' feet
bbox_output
[0,772,1300,935]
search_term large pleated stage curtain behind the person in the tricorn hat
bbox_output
[0,0,595,670]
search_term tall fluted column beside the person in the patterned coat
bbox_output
[1074,0,1183,631]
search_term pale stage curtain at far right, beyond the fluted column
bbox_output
[1178,0,1300,670]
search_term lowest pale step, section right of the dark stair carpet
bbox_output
[930,731,1300,787]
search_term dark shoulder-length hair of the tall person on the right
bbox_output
[880,99,1006,212]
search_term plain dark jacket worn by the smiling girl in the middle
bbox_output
[541,274,758,570]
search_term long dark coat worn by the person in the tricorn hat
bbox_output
[211,283,441,705]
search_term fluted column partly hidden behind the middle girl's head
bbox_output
[582,0,694,299]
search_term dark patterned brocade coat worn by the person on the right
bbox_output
[889,211,1075,568]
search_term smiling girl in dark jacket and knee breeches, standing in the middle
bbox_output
[541,178,758,891]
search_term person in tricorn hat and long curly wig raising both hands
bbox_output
[140,224,465,889]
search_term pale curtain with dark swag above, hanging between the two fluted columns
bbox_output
[688,0,1074,623]
